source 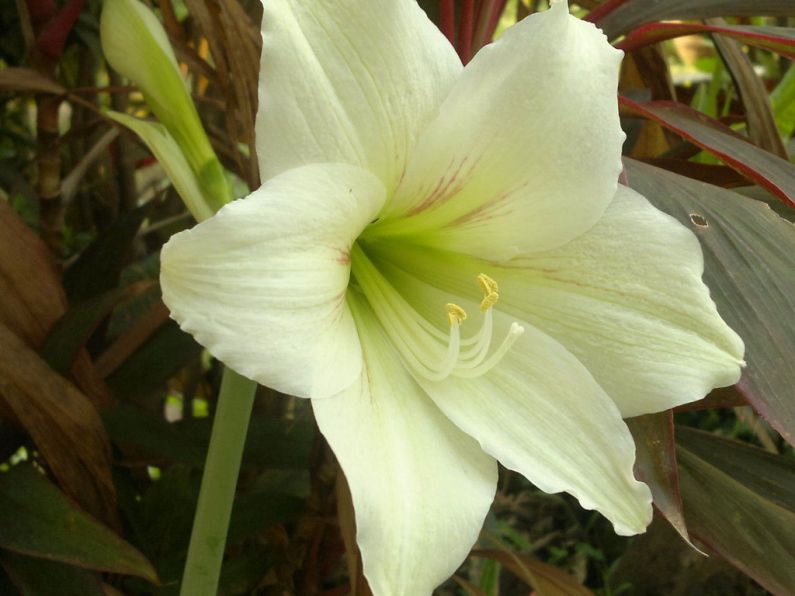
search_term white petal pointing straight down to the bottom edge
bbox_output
[312,296,497,596]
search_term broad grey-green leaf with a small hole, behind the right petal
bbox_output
[625,160,795,444]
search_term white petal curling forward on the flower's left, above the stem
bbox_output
[160,164,384,397]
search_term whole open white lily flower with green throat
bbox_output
[161,0,743,595]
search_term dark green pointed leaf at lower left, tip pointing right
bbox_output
[0,465,157,582]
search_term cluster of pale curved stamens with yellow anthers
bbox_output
[351,244,524,381]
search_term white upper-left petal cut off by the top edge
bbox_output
[257,0,462,191]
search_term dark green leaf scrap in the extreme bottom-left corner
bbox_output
[0,551,105,596]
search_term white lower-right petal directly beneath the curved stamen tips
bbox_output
[372,265,652,535]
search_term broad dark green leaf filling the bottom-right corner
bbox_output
[677,427,795,594]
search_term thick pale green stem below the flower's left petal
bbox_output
[180,368,257,596]
